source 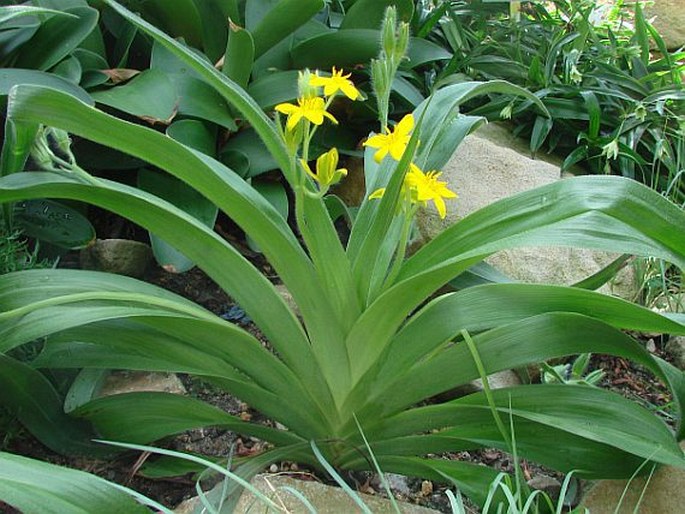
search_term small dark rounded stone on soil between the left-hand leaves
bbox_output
[80,239,152,278]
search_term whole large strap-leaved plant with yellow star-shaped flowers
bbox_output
[0,0,685,501]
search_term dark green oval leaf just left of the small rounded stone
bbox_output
[14,200,95,249]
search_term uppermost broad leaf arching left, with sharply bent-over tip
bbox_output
[9,87,353,408]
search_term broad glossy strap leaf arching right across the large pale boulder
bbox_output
[348,176,685,379]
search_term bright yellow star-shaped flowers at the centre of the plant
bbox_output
[275,68,457,218]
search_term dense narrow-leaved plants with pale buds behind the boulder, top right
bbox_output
[427,0,685,205]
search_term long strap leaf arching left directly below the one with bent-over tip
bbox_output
[0,173,330,420]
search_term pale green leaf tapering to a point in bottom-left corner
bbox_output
[0,452,150,514]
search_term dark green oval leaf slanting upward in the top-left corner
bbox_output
[16,7,99,71]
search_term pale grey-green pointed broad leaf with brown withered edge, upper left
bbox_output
[92,69,179,123]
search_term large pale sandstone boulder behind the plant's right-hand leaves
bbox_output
[417,123,637,299]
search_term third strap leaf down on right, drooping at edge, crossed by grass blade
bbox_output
[349,312,685,431]
